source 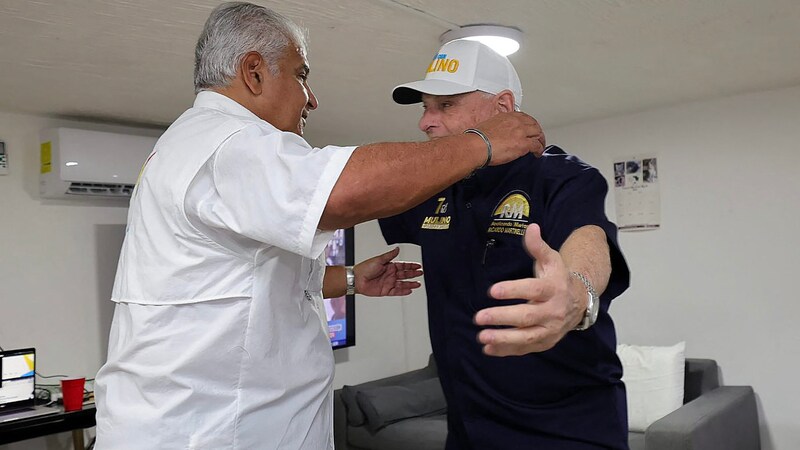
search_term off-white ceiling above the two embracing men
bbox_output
[0,0,800,145]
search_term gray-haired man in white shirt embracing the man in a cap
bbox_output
[95,3,544,450]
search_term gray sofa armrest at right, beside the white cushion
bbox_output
[645,386,761,450]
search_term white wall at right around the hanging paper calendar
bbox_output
[546,87,800,450]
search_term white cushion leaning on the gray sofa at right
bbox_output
[617,342,686,432]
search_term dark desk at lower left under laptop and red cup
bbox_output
[0,404,96,450]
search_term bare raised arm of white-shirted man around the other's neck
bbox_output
[319,112,545,230]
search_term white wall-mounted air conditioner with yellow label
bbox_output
[39,128,158,199]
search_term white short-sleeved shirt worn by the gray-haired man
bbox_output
[95,92,354,450]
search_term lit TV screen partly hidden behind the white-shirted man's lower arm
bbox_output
[323,228,356,349]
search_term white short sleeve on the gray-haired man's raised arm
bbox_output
[213,126,355,258]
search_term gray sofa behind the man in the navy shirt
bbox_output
[334,356,761,450]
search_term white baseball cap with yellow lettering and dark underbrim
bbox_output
[392,39,522,109]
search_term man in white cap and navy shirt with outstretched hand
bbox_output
[380,40,629,450]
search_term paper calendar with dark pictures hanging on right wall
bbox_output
[614,156,661,231]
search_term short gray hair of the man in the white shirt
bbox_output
[194,2,307,93]
